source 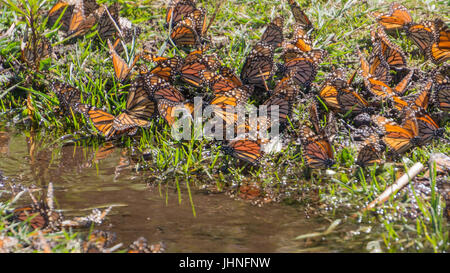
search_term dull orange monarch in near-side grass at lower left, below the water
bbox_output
[12,201,62,230]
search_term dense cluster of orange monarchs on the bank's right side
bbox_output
[312,3,450,167]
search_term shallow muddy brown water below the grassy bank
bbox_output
[0,129,348,252]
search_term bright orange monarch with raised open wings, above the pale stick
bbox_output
[374,114,421,154]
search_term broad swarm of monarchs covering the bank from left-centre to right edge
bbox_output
[47,0,450,168]
